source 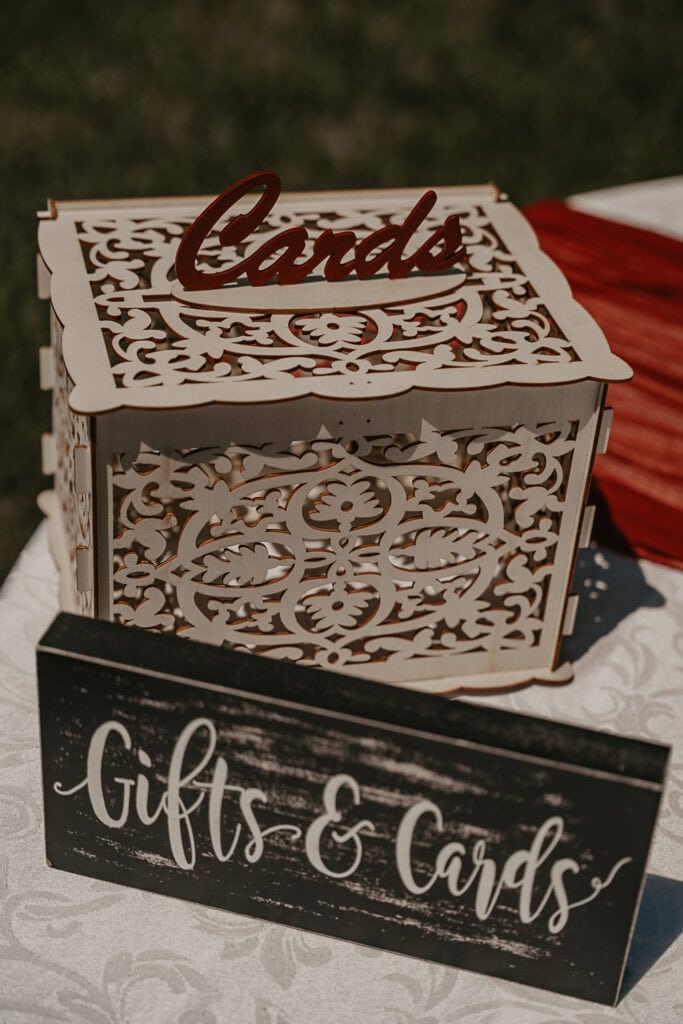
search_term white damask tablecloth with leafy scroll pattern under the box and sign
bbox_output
[0,178,683,1024]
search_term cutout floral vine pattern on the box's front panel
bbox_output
[113,422,577,676]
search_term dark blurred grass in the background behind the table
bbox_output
[0,0,683,580]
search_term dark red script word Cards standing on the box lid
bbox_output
[175,171,465,291]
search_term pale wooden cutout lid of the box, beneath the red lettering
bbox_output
[39,185,631,414]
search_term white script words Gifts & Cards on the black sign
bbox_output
[54,718,632,935]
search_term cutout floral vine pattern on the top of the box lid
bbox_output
[77,200,579,389]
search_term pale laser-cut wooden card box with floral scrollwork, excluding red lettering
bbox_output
[38,186,631,692]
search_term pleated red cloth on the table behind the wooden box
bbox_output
[524,200,683,568]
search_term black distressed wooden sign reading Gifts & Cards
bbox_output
[38,614,668,1002]
